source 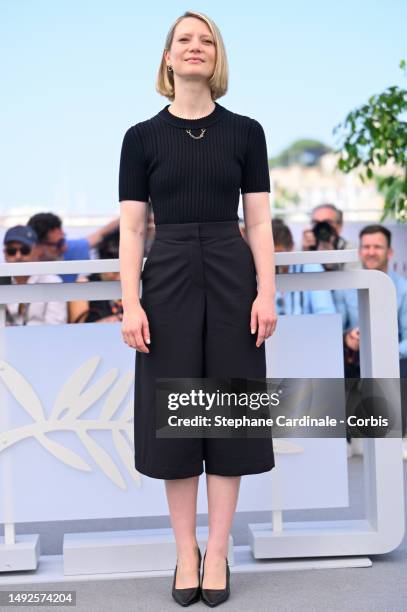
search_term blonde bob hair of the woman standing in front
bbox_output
[156,11,228,102]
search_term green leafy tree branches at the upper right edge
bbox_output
[334,60,407,221]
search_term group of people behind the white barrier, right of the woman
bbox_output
[272,204,407,378]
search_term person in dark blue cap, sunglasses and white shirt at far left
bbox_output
[3,225,67,325]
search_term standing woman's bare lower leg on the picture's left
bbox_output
[165,476,199,589]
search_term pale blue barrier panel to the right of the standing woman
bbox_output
[237,314,349,511]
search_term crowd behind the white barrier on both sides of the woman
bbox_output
[2,204,407,377]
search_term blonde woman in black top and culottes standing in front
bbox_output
[119,12,276,607]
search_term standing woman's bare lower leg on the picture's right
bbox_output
[202,474,241,589]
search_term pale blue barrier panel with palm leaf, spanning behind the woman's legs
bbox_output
[0,315,348,523]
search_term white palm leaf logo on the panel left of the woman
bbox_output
[0,356,141,490]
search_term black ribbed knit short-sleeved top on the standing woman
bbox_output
[119,102,270,225]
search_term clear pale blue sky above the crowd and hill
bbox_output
[0,0,407,215]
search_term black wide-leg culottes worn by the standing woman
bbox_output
[134,221,274,479]
